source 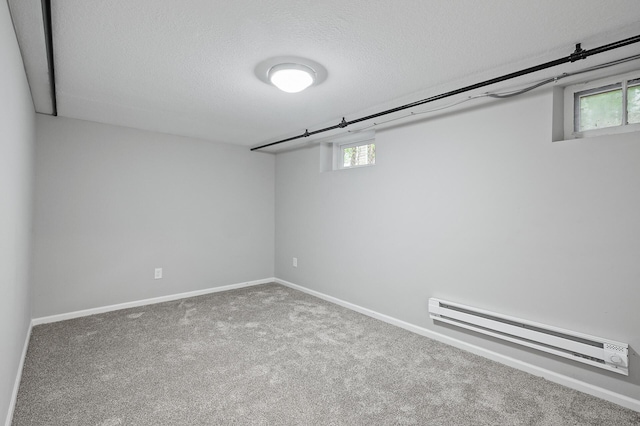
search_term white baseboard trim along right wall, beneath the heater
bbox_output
[274,278,640,412]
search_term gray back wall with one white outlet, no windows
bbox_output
[34,115,275,318]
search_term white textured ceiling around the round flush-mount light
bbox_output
[10,0,640,146]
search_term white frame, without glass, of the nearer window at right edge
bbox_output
[564,70,640,139]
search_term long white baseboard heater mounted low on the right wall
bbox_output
[429,298,629,376]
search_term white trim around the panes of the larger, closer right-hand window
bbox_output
[564,70,640,140]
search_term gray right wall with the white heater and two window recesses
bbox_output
[276,92,640,399]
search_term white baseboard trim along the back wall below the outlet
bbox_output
[31,278,275,326]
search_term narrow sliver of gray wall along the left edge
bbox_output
[0,2,35,422]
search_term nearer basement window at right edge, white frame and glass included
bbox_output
[565,71,640,139]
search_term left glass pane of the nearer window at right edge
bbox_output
[578,89,622,132]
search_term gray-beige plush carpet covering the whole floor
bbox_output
[13,284,640,426]
